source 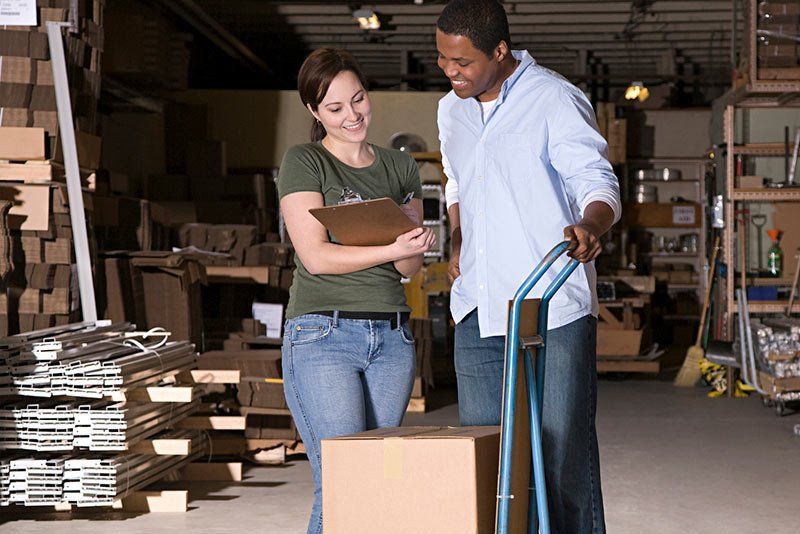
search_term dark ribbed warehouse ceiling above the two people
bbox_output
[186,0,743,96]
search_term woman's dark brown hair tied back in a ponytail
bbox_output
[297,48,367,142]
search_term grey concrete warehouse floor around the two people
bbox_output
[0,380,800,534]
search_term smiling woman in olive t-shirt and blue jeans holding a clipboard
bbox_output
[278,48,435,533]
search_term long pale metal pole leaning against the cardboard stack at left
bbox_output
[47,22,97,322]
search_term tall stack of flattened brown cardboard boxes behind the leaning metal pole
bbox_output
[0,0,105,335]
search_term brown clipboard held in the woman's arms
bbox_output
[308,198,418,247]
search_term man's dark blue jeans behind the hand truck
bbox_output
[455,310,605,534]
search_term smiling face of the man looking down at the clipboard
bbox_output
[436,28,500,98]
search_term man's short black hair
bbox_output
[436,0,511,57]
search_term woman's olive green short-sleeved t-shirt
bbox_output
[277,142,422,319]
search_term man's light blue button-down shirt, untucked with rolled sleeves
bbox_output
[438,50,621,337]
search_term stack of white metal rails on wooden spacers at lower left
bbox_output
[0,323,207,506]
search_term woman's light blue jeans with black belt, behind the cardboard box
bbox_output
[282,314,415,534]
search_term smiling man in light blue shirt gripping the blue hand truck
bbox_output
[436,0,621,534]
